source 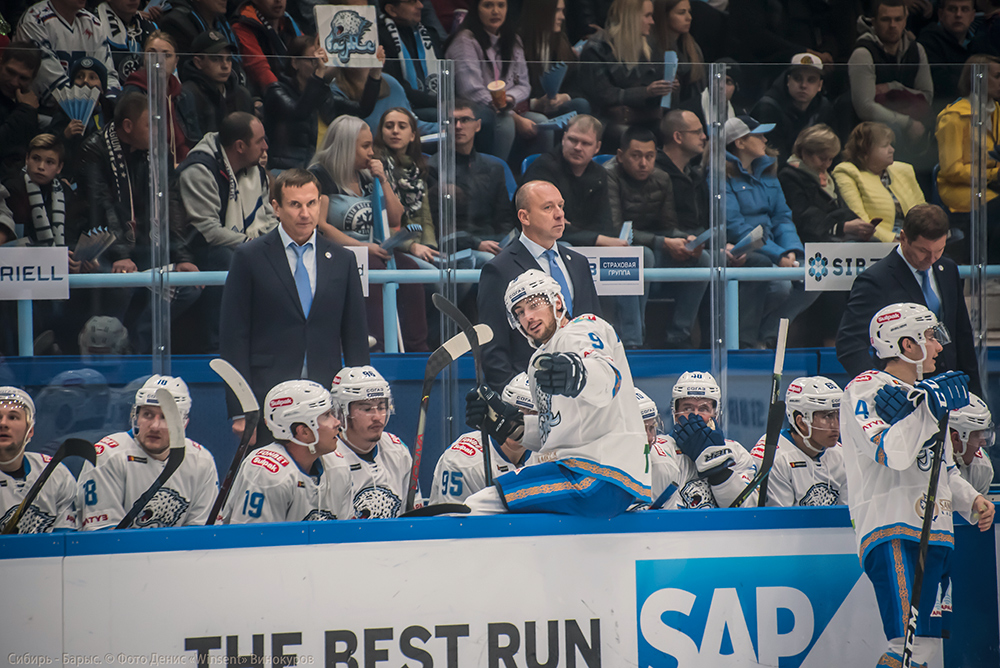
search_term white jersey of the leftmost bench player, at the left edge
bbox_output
[0,452,76,533]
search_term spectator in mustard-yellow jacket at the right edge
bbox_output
[936,55,1000,218]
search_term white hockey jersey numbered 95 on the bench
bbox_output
[431,431,531,503]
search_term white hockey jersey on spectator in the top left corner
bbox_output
[17,0,120,98]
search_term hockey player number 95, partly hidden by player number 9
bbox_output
[431,373,538,503]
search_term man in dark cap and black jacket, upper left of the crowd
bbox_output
[181,30,254,142]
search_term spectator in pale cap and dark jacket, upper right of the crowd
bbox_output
[750,53,831,168]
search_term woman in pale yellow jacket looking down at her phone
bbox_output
[833,121,924,242]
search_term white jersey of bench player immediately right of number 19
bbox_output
[336,431,414,519]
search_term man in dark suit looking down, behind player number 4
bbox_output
[837,204,982,394]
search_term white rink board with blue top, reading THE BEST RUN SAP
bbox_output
[0,508,1000,668]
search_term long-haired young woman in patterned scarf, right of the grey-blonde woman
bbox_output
[375,107,438,262]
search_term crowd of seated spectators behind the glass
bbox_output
[0,0,1000,354]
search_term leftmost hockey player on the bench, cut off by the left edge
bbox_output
[0,387,76,533]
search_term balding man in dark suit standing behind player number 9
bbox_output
[478,181,601,392]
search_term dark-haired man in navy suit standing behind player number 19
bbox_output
[220,169,369,444]
